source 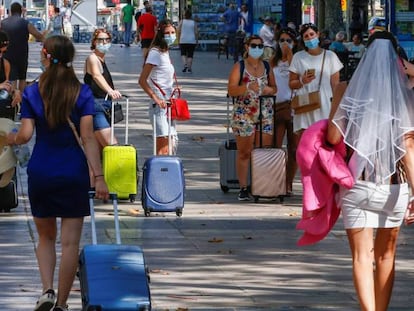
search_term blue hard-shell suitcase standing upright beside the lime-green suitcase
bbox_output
[141,107,185,216]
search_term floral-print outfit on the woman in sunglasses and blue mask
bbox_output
[231,69,273,137]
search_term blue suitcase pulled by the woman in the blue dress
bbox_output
[79,192,151,311]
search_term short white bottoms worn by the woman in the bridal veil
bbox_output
[337,180,409,229]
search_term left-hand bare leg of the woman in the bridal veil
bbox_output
[346,228,377,311]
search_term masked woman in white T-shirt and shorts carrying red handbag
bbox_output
[138,20,178,155]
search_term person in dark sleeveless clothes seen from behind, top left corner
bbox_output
[0,2,44,92]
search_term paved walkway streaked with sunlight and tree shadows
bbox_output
[0,43,414,311]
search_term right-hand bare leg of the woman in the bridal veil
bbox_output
[374,227,400,311]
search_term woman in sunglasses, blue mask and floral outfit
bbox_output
[227,35,277,201]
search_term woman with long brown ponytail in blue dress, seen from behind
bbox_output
[8,36,109,311]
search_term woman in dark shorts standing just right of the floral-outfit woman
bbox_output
[270,28,297,196]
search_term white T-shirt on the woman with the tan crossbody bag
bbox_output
[289,50,343,131]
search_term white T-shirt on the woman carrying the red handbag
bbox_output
[145,48,174,98]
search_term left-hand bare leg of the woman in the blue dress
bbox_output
[34,217,57,292]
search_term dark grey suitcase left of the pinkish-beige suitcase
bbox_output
[218,95,250,192]
